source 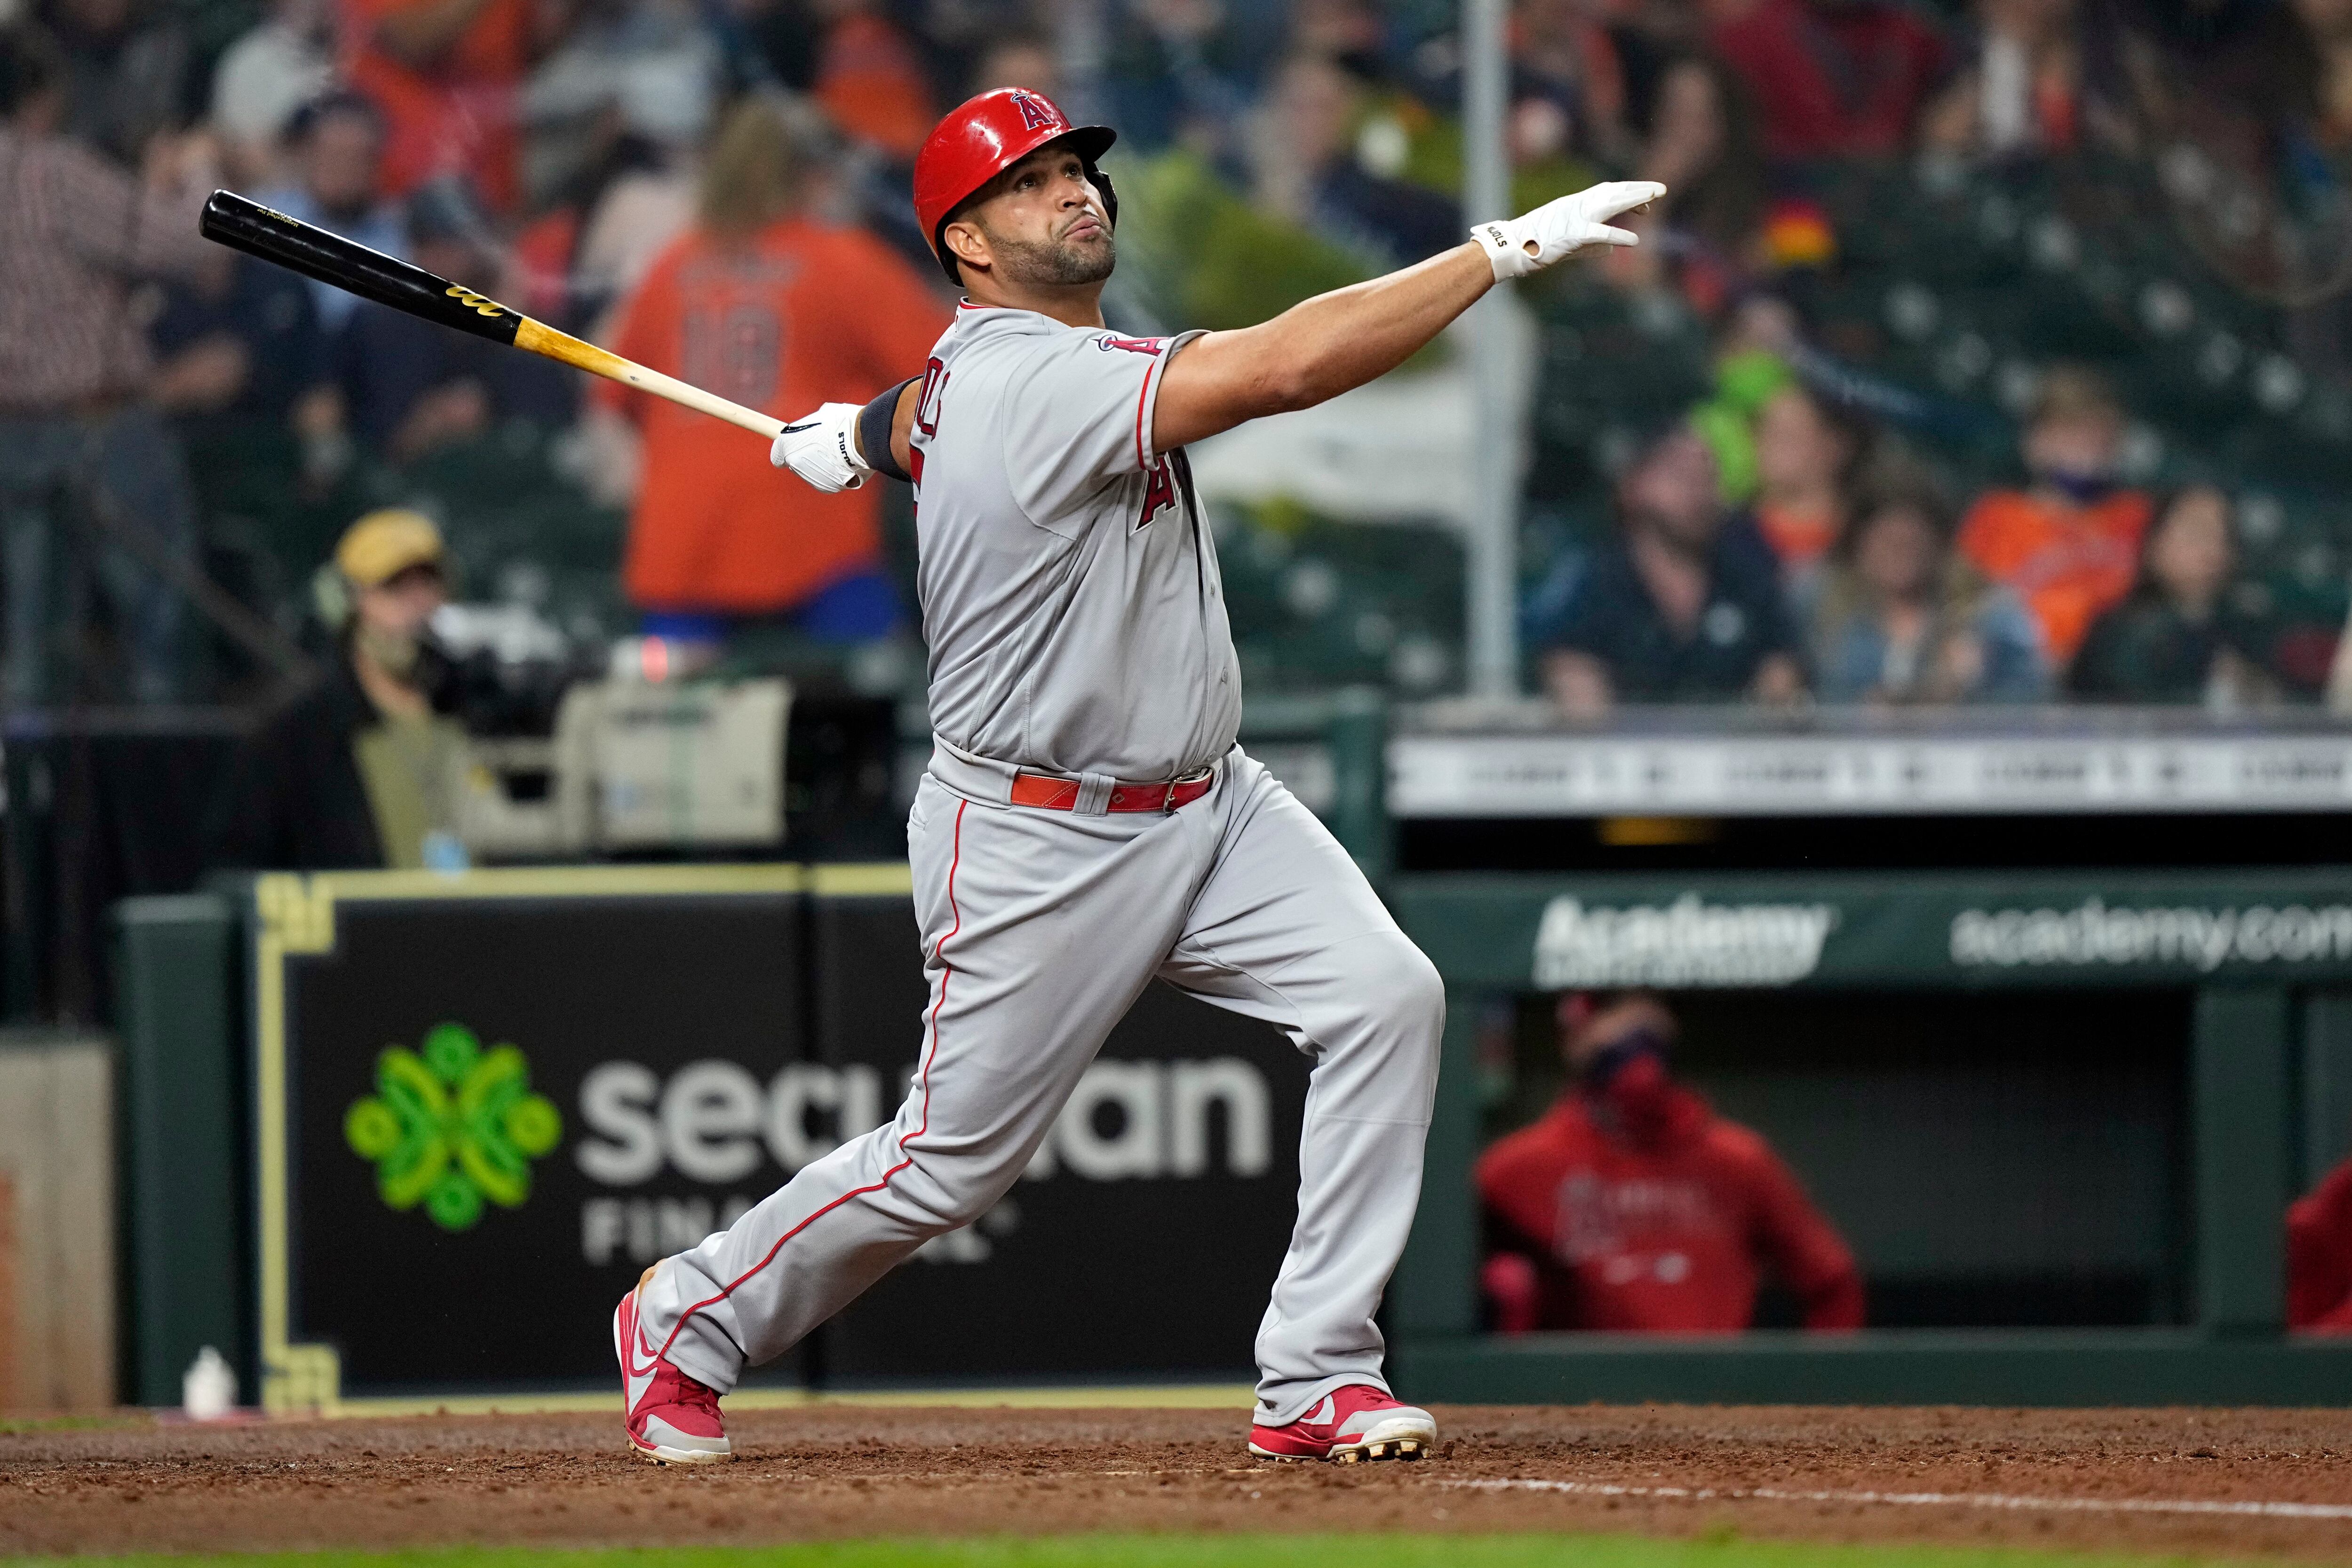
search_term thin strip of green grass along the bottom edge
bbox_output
[0,1528,2296,1568]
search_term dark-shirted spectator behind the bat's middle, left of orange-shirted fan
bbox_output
[334,179,576,463]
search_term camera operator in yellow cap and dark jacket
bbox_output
[207,510,468,870]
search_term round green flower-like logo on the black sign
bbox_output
[343,1023,564,1229]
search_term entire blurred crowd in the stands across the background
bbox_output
[0,0,2352,715]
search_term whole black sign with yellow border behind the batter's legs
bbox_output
[254,865,1305,1408]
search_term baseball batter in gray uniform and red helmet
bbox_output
[614,89,1665,1462]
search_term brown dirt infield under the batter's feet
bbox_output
[0,1401,2352,1563]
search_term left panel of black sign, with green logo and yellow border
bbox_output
[254,865,807,1408]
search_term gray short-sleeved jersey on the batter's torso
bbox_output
[910,303,1242,780]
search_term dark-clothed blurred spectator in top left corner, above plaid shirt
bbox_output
[38,0,195,169]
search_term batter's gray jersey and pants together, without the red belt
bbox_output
[640,306,1444,1425]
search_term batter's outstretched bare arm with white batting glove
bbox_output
[1152,181,1665,451]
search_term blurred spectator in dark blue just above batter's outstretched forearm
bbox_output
[1251,54,1463,273]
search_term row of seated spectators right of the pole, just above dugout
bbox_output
[1541,367,2277,717]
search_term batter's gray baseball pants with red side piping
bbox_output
[640,748,1444,1425]
